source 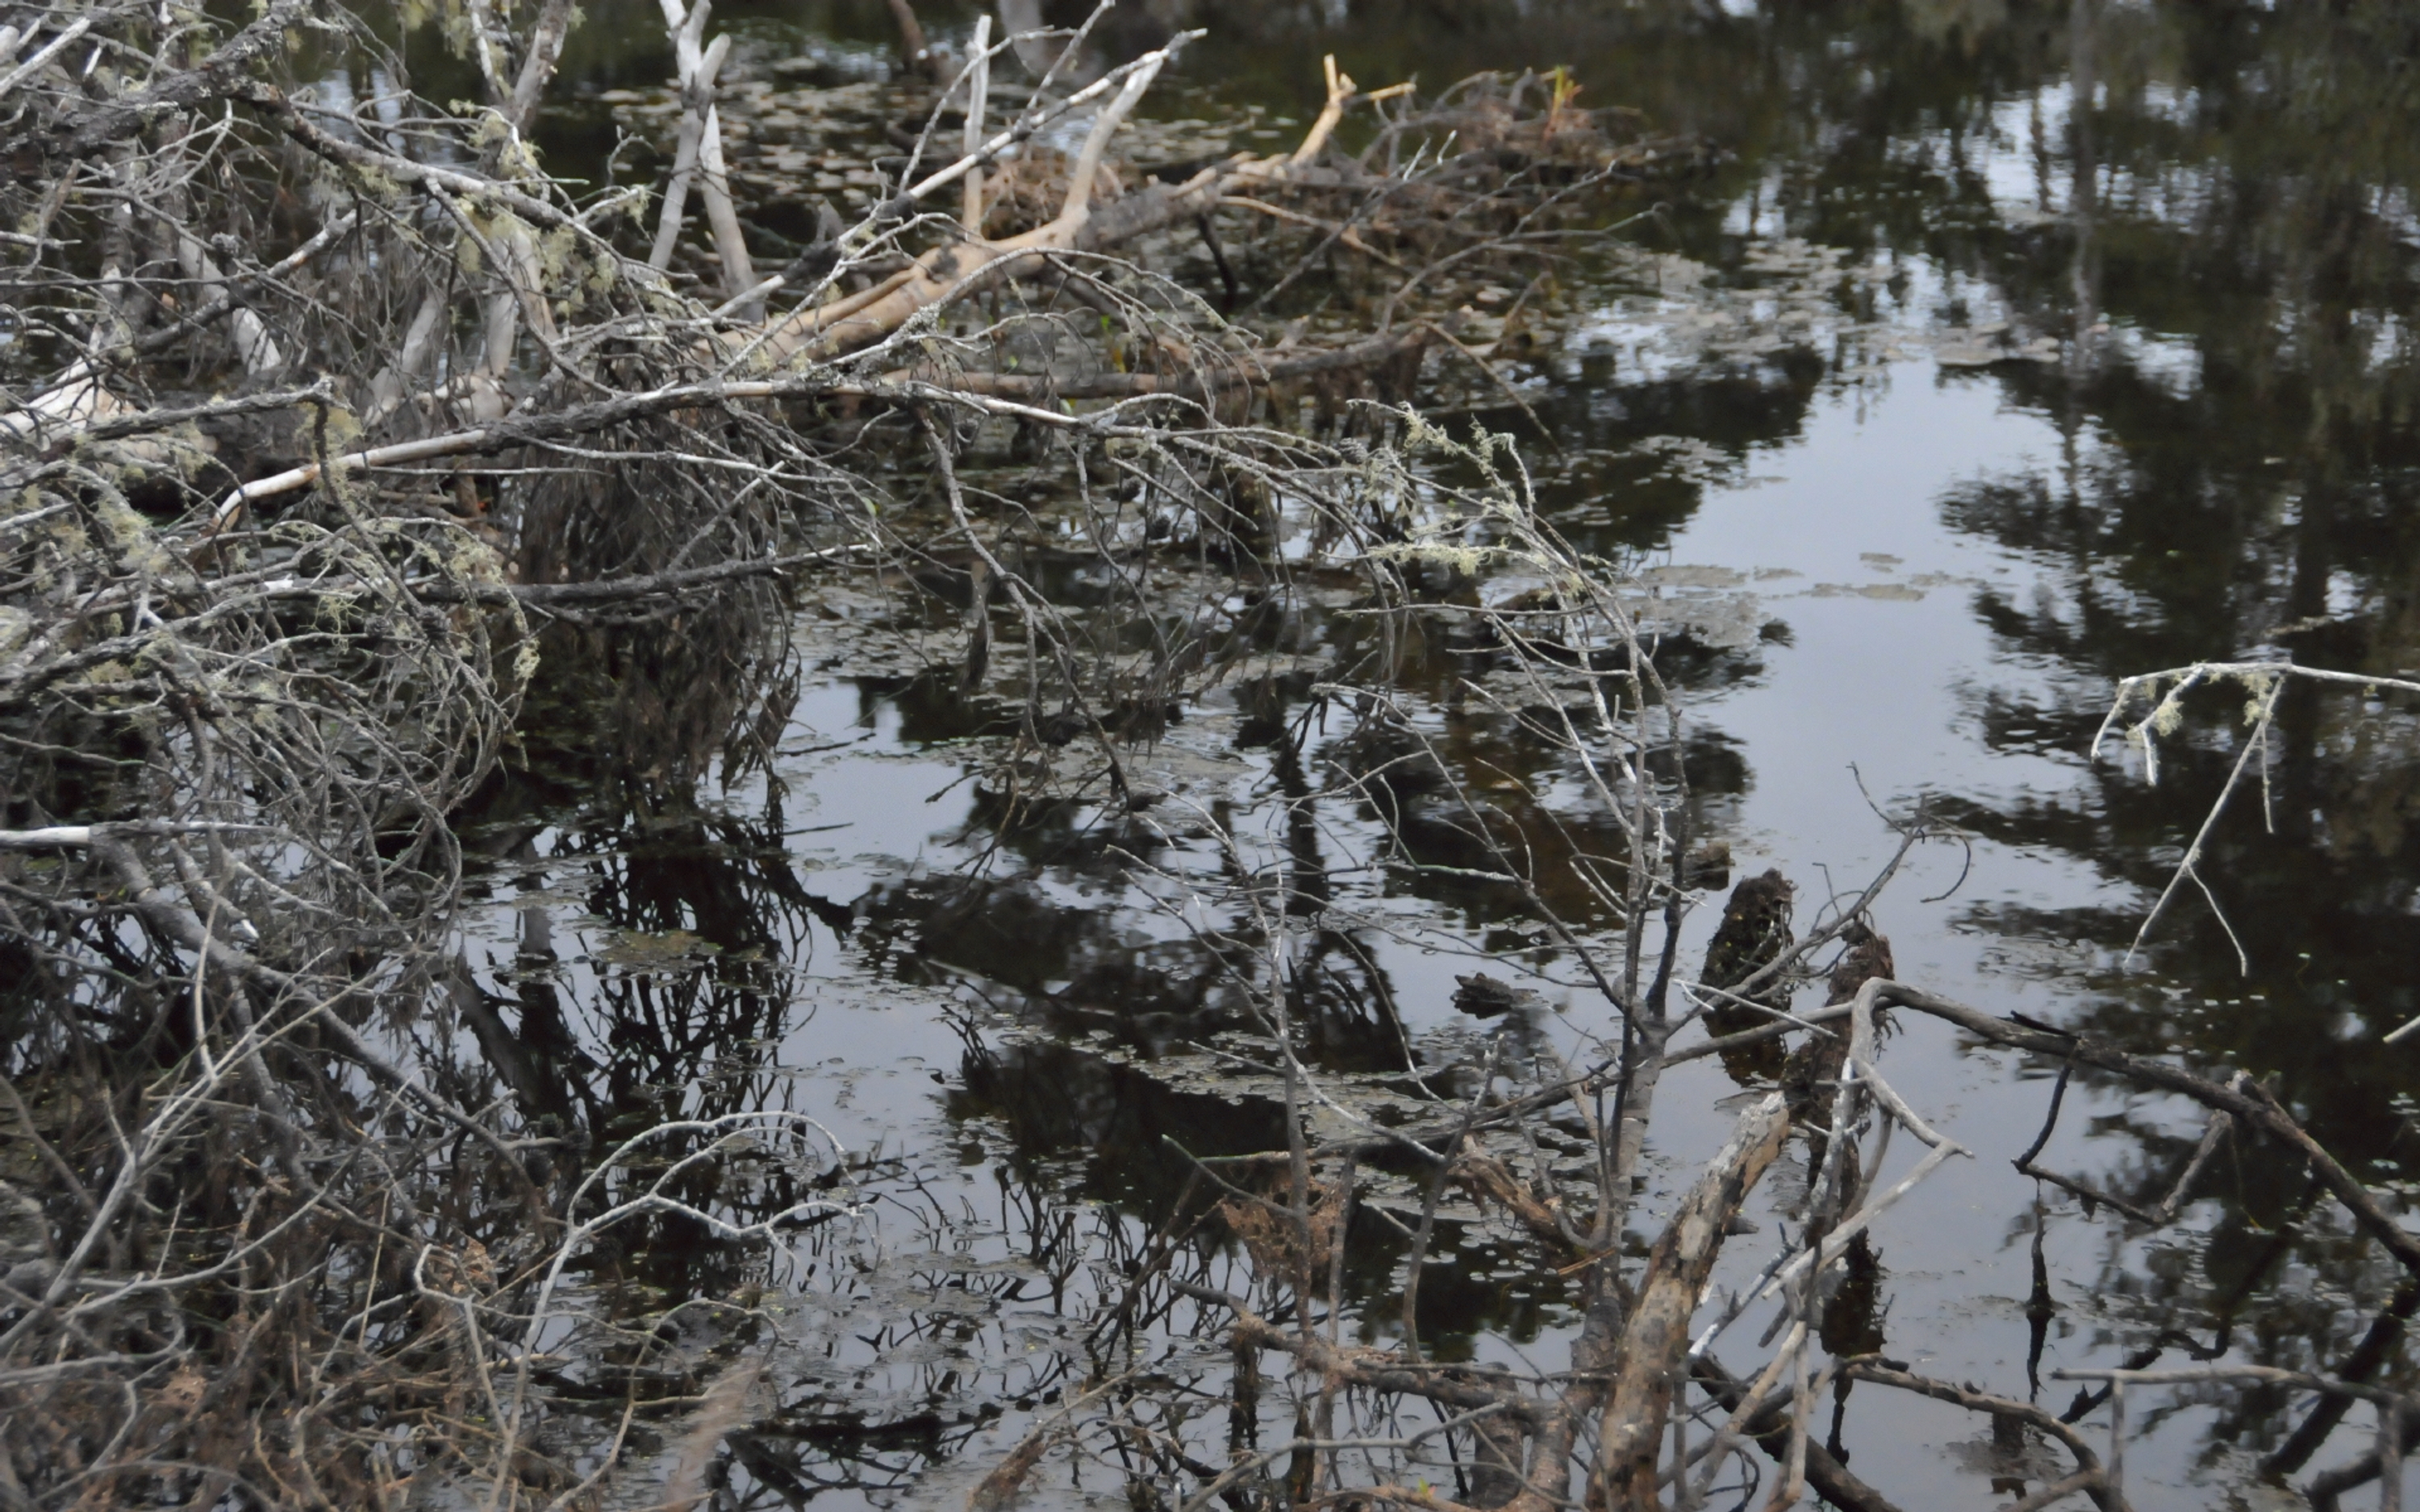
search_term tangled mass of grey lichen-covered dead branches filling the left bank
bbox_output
[0,0,1713,1507]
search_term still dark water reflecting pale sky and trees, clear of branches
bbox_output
[455,0,2420,1507]
